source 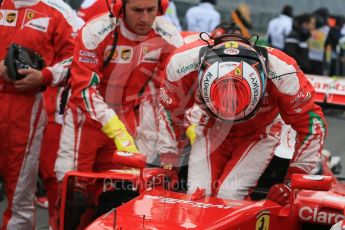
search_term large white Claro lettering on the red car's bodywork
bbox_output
[298,206,345,225]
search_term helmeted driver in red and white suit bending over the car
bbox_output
[158,35,326,204]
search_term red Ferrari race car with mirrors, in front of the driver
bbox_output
[61,147,345,230]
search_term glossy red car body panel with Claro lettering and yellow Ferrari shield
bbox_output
[83,175,345,230]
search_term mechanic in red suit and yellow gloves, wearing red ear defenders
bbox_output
[55,0,183,227]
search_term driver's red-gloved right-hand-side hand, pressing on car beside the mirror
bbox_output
[267,183,291,206]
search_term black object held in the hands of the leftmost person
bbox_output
[4,43,45,81]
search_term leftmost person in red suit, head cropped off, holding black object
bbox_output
[0,0,76,229]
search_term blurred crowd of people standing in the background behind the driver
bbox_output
[67,0,345,76]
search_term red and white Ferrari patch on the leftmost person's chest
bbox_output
[22,9,50,32]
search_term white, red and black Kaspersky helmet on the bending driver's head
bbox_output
[198,35,267,122]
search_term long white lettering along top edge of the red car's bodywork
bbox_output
[145,195,242,209]
